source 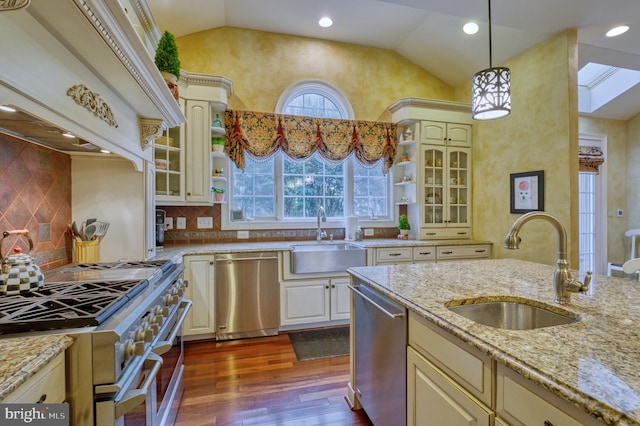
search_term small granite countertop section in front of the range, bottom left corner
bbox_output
[0,335,73,401]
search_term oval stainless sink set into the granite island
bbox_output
[445,298,580,330]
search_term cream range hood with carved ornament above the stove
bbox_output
[0,0,186,170]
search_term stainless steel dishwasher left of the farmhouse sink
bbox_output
[214,252,280,340]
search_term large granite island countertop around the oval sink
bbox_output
[348,259,640,425]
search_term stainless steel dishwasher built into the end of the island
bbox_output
[350,282,407,426]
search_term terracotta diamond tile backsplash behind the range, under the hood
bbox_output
[0,133,71,270]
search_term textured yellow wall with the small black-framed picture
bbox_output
[455,31,578,265]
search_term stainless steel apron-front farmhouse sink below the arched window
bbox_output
[291,243,367,274]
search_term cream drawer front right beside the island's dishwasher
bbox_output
[409,312,493,405]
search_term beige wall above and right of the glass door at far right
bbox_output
[579,117,628,262]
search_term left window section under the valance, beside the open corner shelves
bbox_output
[231,156,275,217]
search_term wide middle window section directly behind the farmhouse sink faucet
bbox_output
[284,155,344,218]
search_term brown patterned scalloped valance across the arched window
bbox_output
[225,110,398,174]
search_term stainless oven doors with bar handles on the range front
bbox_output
[96,300,191,426]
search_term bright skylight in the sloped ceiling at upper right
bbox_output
[578,62,640,113]
